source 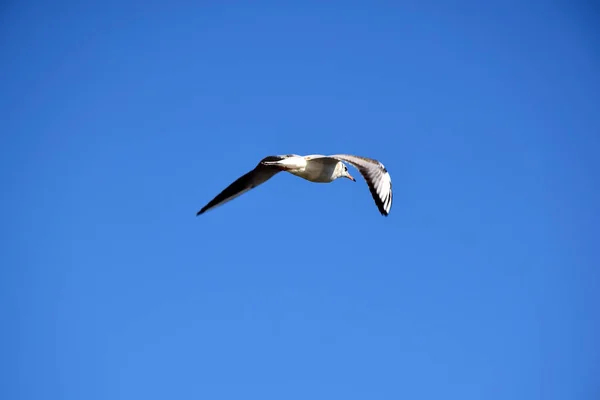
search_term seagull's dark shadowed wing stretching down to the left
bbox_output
[196,156,283,216]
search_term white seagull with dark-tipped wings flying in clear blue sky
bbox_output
[196,154,392,216]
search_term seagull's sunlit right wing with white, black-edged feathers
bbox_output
[329,154,392,216]
